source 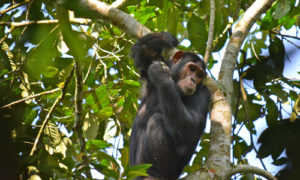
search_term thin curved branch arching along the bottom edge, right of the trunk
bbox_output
[225,164,277,180]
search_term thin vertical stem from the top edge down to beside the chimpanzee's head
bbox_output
[204,0,215,64]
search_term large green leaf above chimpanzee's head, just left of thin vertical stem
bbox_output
[187,15,208,55]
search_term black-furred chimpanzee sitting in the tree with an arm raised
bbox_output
[130,32,210,180]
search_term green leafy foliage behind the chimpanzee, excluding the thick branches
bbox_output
[0,0,300,179]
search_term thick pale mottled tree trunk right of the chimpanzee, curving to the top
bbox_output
[207,0,274,178]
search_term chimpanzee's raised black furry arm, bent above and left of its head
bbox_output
[131,32,178,78]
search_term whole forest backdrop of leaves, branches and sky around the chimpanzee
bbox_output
[0,0,300,180]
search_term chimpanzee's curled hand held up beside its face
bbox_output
[148,61,170,83]
